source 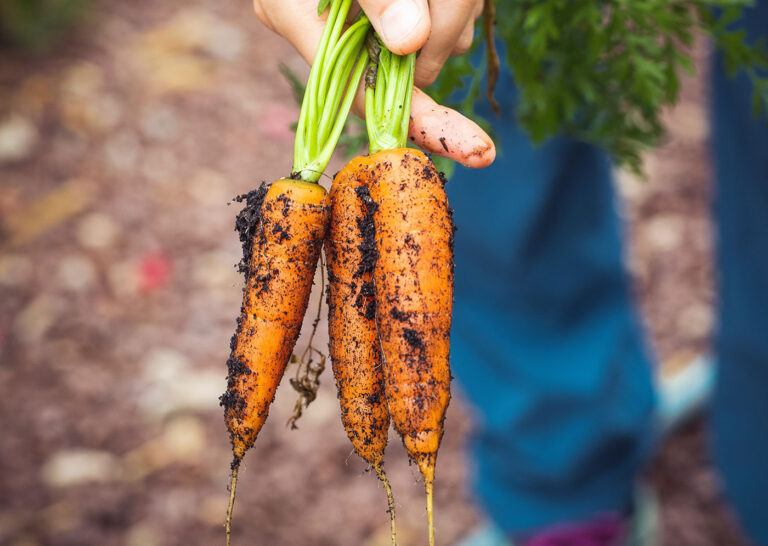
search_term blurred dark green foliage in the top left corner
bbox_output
[0,0,88,50]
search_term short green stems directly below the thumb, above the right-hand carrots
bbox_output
[365,34,416,154]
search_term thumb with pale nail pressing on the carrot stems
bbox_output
[358,0,432,55]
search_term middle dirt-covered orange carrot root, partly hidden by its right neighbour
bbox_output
[325,157,396,545]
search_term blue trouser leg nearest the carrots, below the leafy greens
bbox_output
[447,70,655,533]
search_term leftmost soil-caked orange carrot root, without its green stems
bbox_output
[221,179,328,536]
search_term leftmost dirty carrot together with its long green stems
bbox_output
[221,0,370,545]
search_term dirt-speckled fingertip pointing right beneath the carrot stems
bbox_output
[408,89,496,168]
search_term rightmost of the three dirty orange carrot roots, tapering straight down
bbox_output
[370,148,453,544]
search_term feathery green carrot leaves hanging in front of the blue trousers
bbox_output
[430,0,768,172]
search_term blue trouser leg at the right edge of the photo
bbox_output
[712,2,768,545]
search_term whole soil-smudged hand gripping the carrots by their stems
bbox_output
[249,0,496,167]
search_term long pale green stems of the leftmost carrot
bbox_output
[292,0,371,182]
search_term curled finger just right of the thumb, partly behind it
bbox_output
[414,0,478,87]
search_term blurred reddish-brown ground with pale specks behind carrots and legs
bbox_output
[0,0,756,546]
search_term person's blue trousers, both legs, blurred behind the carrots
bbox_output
[447,3,768,544]
